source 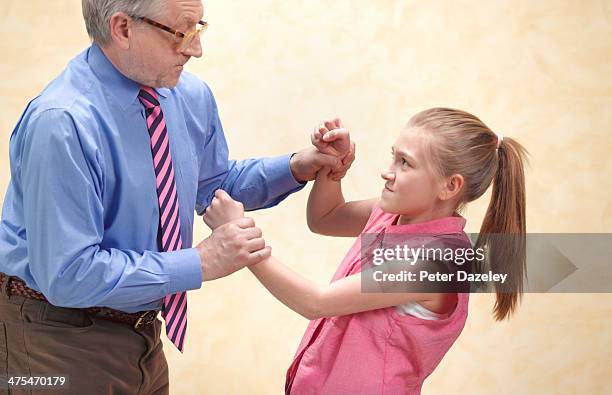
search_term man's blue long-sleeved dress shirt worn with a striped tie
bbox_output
[0,44,303,312]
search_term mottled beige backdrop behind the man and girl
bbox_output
[0,0,612,394]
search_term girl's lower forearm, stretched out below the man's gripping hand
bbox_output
[249,257,324,320]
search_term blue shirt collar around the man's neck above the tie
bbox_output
[87,44,170,110]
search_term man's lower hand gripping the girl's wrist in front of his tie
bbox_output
[196,218,272,281]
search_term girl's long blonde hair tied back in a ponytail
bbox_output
[408,108,527,321]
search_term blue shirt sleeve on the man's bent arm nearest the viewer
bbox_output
[19,109,201,308]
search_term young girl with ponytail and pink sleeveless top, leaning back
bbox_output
[204,108,525,395]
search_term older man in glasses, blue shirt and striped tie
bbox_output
[0,0,352,394]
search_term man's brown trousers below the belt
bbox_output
[0,289,169,395]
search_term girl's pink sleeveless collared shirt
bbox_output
[285,205,471,395]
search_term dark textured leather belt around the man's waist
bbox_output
[0,273,159,330]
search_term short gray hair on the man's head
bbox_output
[82,0,165,46]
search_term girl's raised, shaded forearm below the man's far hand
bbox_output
[306,168,345,233]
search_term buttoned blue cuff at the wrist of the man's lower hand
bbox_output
[164,248,202,295]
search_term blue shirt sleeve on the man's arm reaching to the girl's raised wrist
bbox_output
[196,86,306,215]
